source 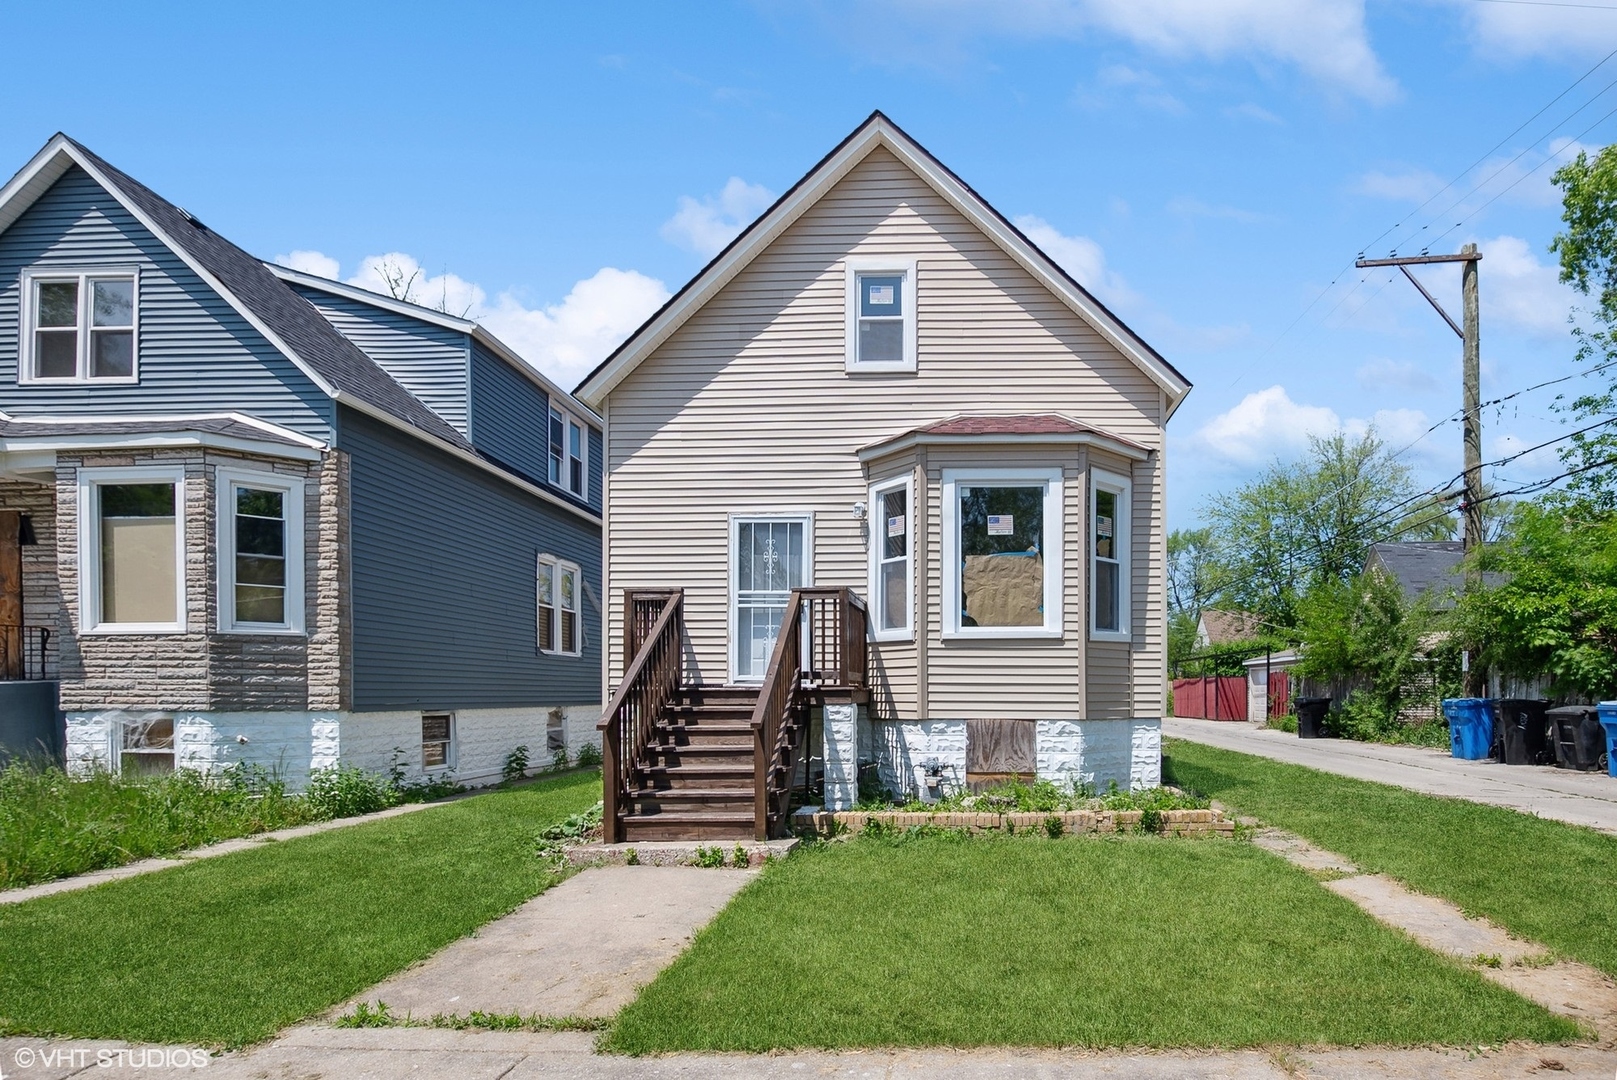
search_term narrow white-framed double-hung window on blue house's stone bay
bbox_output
[217,469,304,632]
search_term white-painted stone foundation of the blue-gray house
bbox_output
[66,705,600,789]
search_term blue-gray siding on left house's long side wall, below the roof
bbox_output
[338,409,602,710]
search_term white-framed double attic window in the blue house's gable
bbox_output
[18,270,136,383]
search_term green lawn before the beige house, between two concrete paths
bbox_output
[605,836,1577,1054]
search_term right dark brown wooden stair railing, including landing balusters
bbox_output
[752,589,868,841]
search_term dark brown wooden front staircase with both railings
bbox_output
[600,589,867,844]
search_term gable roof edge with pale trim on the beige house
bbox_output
[572,110,1190,416]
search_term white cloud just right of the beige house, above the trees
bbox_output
[1192,385,1431,467]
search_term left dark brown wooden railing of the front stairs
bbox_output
[598,589,686,844]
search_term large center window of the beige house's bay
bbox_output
[943,469,1062,639]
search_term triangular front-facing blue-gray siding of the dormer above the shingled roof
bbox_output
[291,283,471,435]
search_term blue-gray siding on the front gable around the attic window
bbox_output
[0,168,333,438]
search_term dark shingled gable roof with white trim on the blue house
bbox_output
[0,133,600,521]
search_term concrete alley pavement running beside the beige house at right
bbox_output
[1163,718,1617,834]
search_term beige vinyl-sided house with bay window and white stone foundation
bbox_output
[577,113,1188,821]
